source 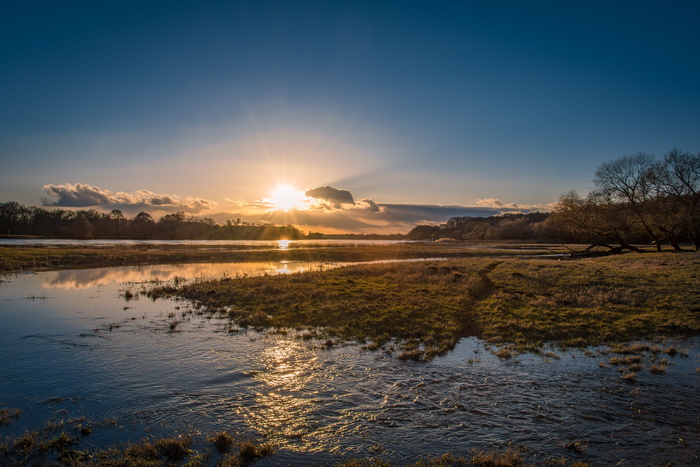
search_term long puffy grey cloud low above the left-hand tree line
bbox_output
[42,183,217,214]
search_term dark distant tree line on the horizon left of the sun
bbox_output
[0,201,304,240]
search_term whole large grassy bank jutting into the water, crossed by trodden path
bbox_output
[149,253,700,360]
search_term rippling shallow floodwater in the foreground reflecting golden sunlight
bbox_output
[0,263,700,465]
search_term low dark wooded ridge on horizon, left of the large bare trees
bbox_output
[406,212,554,241]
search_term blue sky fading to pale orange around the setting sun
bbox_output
[0,0,700,232]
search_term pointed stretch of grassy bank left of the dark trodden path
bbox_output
[149,263,488,360]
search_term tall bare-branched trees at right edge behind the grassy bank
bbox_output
[549,149,700,251]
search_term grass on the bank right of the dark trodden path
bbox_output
[478,253,700,353]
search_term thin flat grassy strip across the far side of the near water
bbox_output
[0,243,561,273]
